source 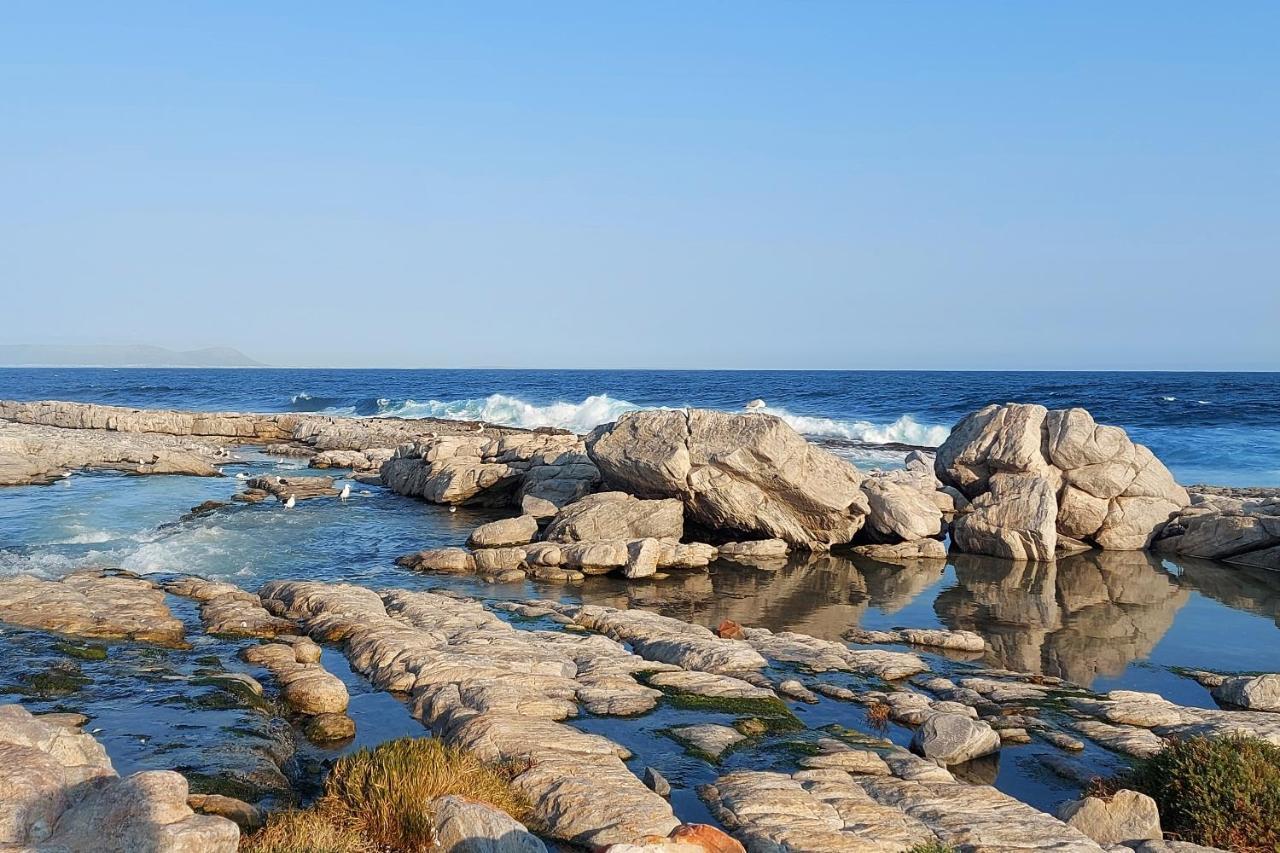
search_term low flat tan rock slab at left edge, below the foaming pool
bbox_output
[0,570,184,646]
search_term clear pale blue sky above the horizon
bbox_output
[0,0,1280,370]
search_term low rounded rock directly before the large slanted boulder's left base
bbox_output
[543,492,685,542]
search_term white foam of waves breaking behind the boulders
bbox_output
[360,394,950,447]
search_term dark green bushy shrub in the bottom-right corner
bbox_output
[1096,736,1280,853]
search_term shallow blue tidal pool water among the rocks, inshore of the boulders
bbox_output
[0,466,1280,820]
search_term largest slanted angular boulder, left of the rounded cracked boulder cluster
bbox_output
[586,409,868,551]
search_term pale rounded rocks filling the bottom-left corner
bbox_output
[0,704,239,853]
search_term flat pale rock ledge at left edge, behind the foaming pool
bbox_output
[0,417,220,485]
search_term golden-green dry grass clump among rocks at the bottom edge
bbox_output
[241,738,530,853]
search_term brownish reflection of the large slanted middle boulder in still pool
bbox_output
[582,553,943,640]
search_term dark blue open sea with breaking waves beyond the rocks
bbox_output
[0,368,1280,485]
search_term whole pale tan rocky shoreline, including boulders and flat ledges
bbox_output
[0,394,1280,853]
